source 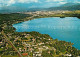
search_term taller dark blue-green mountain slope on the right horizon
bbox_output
[48,3,80,10]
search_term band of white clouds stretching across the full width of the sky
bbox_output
[0,0,80,7]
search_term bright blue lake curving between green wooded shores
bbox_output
[13,17,80,49]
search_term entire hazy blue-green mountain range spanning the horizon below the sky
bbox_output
[0,3,80,13]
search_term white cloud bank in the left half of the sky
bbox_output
[0,0,38,6]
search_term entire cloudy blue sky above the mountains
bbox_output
[0,0,80,9]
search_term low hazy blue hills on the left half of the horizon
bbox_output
[0,8,44,13]
